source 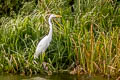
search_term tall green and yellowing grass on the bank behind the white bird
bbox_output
[0,0,120,76]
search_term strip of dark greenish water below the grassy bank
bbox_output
[0,73,112,80]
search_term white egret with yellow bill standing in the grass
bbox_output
[34,14,61,59]
